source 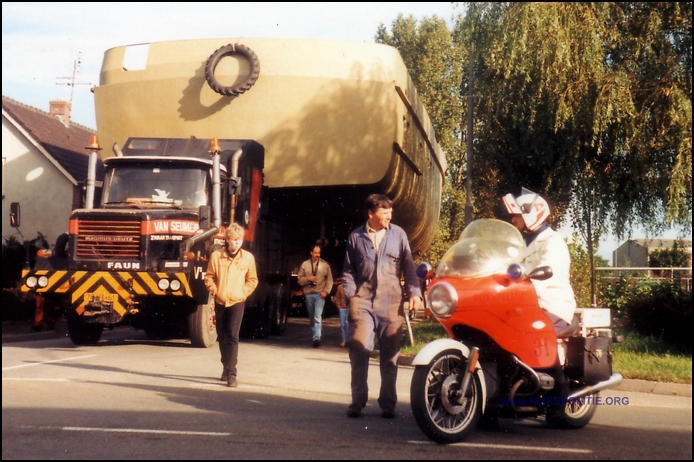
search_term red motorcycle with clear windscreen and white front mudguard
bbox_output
[410,219,622,444]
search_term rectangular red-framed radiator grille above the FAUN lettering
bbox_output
[76,220,140,259]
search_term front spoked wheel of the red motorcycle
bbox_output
[410,350,482,444]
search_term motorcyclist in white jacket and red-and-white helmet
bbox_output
[503,188,576,333]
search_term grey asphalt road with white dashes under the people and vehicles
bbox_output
[2,318,692,460]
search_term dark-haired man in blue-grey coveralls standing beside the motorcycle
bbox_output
[342,194,422,419]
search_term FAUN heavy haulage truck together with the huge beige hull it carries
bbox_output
[22,39,446,347]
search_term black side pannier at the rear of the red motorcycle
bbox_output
[566,337,612,383]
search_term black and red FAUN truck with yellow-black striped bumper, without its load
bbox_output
[25,138,266,347]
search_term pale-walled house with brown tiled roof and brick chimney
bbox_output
[2,95,104,251]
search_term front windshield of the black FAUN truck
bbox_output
[102,164,208,208]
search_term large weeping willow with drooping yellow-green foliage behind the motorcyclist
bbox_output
[462,2,692,300]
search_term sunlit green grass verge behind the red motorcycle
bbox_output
[401,318,692,384]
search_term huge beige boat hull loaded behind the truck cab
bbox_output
[94,38,445,251]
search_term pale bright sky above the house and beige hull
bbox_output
[2,2,691,264]
